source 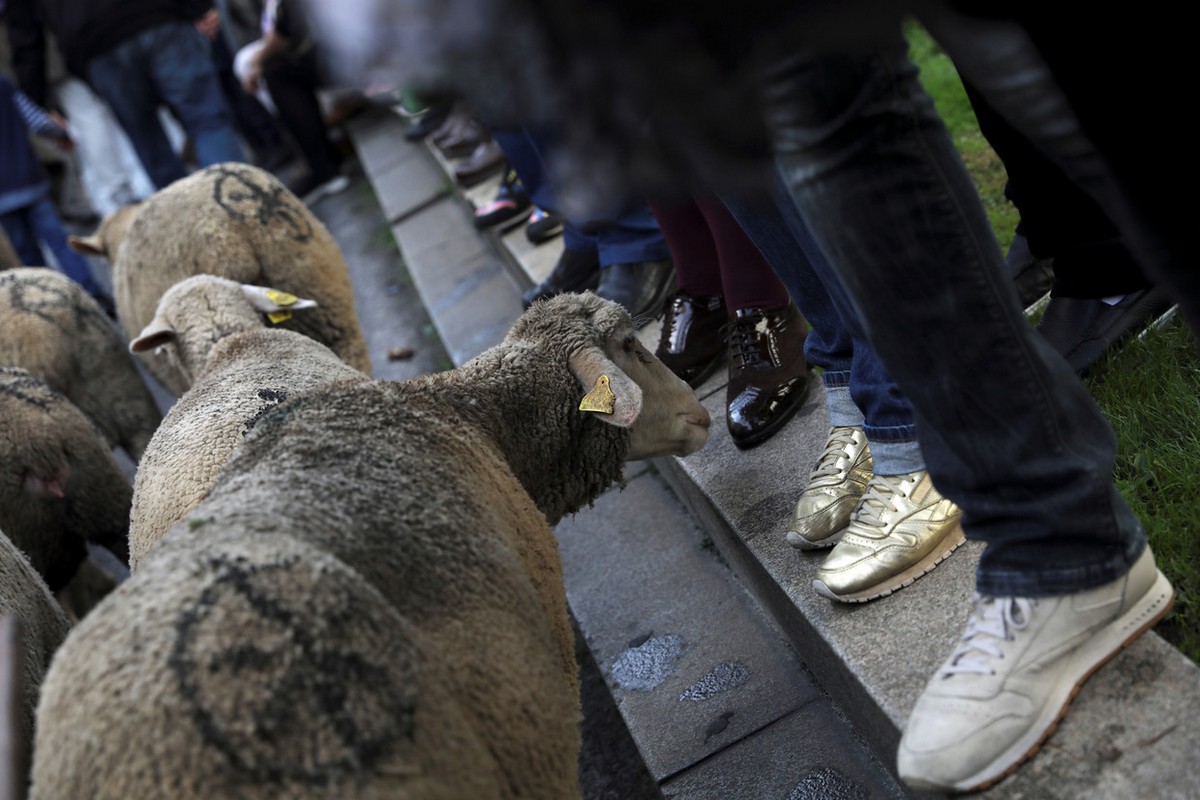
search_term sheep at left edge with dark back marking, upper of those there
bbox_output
[0,267,162,463]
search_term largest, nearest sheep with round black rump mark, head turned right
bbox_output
[31,294,709,800]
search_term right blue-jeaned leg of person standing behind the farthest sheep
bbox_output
[138,23,246,167]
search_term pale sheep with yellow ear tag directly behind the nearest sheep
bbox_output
[130,275,368,570]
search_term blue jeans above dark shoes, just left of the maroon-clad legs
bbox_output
[492,128,671,269]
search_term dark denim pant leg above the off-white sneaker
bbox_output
[764,42,1145,596]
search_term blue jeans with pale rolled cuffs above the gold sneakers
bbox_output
[722,182,925,475]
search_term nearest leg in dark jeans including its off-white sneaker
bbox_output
[766,35,1170,789]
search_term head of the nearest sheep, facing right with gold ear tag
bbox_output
[514,293,710,461]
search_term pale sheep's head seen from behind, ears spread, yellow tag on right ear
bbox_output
[130,275,317,385]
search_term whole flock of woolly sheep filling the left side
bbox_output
[0,164,709,800]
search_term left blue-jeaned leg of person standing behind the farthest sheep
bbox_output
[88,37,187,188]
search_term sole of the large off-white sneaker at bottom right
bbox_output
[900,570,1175,792]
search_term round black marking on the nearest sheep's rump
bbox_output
[169,555,416,783]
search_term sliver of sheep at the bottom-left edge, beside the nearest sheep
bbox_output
[0,530,68,789]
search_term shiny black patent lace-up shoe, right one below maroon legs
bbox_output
[725,303,809,450]
